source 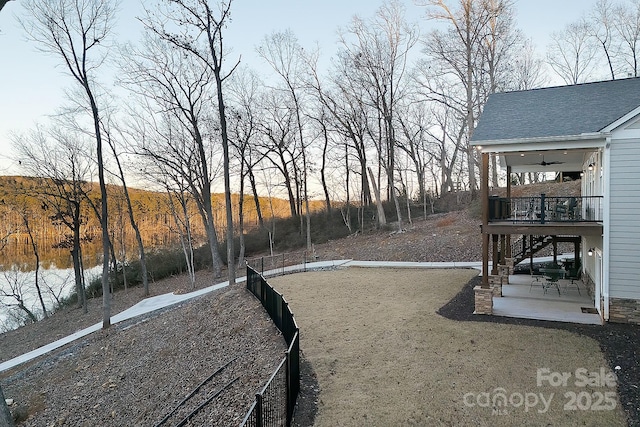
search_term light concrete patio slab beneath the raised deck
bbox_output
[493,274,602,325]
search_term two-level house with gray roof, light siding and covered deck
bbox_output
[471,78,640,324]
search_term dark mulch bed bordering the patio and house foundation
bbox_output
[438,277,640,427]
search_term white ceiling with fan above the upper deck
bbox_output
[497,149,594,173]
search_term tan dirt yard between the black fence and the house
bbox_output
[269,268,627,426]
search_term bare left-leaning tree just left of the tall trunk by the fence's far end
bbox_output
[121,37,223,277]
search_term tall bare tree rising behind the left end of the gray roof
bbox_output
[421,0,514,196]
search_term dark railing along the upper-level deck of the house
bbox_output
[489,194,603,224]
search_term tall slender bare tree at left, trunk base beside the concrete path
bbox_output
[22,0,117,328]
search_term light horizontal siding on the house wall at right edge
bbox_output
[609,139,640,299]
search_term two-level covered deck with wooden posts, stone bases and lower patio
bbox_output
[475,146,604,324]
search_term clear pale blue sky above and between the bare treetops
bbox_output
[0,0,596,175]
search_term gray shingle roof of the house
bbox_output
[472,78,640,142]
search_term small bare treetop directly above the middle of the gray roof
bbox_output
[547,21,596,84]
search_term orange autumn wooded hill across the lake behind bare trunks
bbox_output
[0,176,323,267]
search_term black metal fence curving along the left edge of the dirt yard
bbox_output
[242,265,300,427]
